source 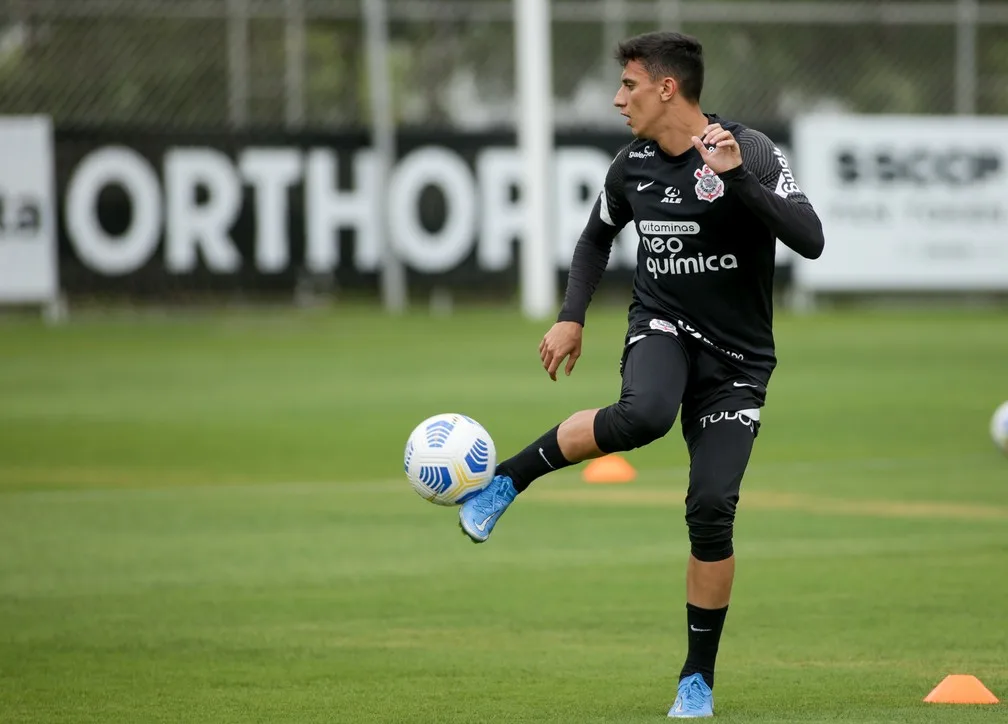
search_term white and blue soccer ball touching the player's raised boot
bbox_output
[404,413,497,505]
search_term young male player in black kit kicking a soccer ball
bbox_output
[460,32,824,718]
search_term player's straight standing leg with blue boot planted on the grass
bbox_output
[668,410,759,718]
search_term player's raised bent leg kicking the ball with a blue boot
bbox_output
[459,334,689,542]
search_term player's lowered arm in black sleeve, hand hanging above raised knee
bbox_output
[539,146,633,381]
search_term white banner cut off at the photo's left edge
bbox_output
[0,116,58,304]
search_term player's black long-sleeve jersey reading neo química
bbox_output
[557,116,824,385]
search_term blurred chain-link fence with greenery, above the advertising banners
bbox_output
[0,0,1008,129]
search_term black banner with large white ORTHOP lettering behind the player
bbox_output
[56,129,789,295]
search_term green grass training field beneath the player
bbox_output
[0,302,1008,723]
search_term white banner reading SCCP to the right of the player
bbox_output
[792,115,1008,291]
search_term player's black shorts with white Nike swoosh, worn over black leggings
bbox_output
[620,321,766,442]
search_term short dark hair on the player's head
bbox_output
[616,32,704,103]
